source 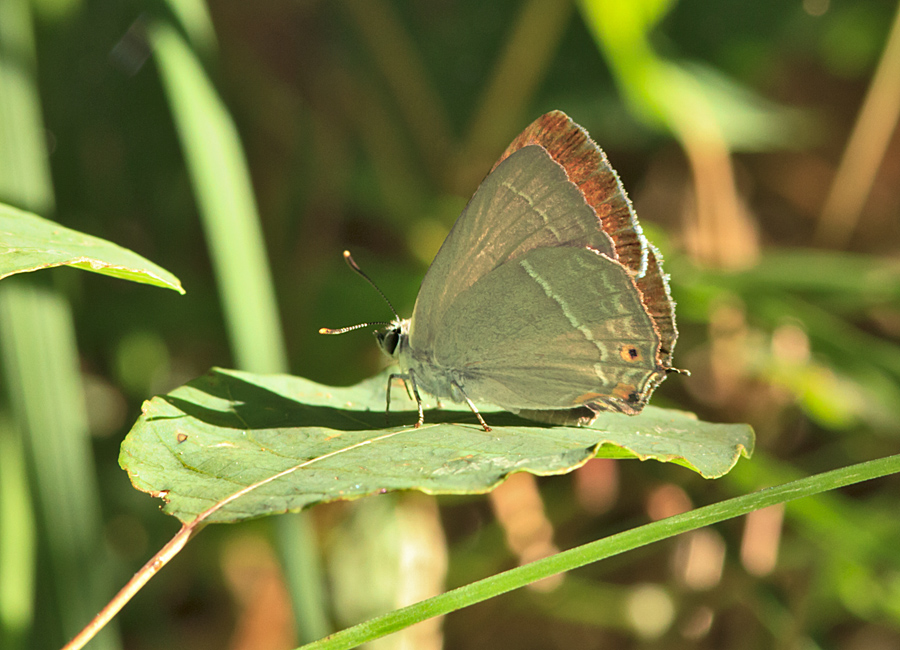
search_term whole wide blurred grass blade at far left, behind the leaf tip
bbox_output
[0,0,120,650]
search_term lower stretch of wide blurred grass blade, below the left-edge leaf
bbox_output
[0,277,119,648]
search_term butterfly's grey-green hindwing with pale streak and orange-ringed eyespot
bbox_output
[432,247,664,413]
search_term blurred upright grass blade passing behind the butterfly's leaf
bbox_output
[149,17,329,640]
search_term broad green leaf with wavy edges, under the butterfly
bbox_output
[119,369,754,522]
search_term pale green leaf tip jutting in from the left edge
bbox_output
[0,204,184,294]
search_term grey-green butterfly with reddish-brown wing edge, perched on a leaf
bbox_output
[320,111,680,431]
